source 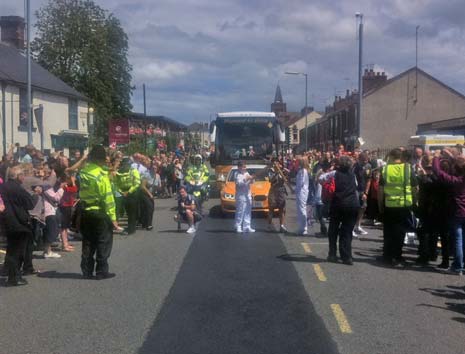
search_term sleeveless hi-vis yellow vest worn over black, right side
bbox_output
[383,163,413,208]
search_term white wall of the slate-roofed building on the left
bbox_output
[0,86,88,153]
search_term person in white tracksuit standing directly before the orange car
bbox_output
[235,161,255,232]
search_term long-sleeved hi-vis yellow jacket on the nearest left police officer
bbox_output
[79,163,116,221]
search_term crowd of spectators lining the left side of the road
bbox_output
[0,144,207,284]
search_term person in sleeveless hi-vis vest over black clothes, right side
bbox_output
[378,149,417,265]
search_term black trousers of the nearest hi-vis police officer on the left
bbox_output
[81,210,113,276]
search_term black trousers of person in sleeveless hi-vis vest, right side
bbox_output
[383,208,412,260]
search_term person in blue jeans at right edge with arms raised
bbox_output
[433,149,465,275]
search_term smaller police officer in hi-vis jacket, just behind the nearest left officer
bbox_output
[116,158,141,235]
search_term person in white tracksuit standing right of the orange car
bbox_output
[295,157,309,235]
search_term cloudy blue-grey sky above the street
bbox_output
[0,0,465,123]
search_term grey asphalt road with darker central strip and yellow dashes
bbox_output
[0,200,465,354]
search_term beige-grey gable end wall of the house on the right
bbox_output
[361,71,465,149]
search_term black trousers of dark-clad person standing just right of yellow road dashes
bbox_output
[328,207,359,261]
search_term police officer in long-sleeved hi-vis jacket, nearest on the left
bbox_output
[80,145,118,280]
